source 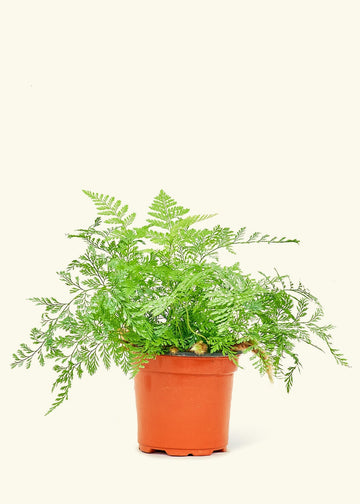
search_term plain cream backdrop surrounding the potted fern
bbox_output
[0,0,360,504]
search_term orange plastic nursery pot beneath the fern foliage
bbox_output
[134,355,237,455]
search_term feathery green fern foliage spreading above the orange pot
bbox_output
[11,190,348,413]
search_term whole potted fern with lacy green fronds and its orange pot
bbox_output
[11,190,348,455]
